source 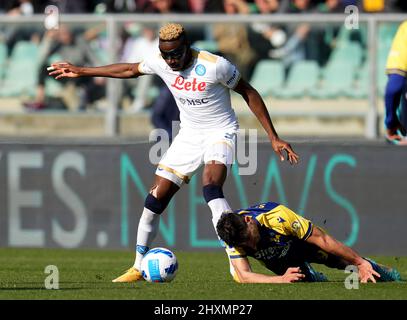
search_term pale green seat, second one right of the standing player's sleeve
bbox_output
[274,61,320,99]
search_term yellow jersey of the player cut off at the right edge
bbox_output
[386,21,407,77]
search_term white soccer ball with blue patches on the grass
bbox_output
[141,248,178,282]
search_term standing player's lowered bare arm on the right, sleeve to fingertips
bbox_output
[234,79,299,164]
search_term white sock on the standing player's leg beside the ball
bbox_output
[133,208,160,270]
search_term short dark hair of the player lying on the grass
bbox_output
[216,212,248,247]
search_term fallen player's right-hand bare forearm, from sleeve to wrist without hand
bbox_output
[306,227,364,266]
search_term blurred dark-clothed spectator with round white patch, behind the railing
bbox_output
[249,0,286,60]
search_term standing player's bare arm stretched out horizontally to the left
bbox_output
[47,62,142,80]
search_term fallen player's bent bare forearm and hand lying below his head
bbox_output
[232,258,305,283]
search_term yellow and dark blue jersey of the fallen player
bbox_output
[226,202,313,267]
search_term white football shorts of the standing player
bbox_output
[155,128,237,187]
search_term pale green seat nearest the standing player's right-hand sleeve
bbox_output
[250,60,284,97]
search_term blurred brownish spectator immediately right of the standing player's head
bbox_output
[213,0,256,79]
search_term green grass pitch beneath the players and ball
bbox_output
[0,248,407,300]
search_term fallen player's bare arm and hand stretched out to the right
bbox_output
[305,226,380,283]
